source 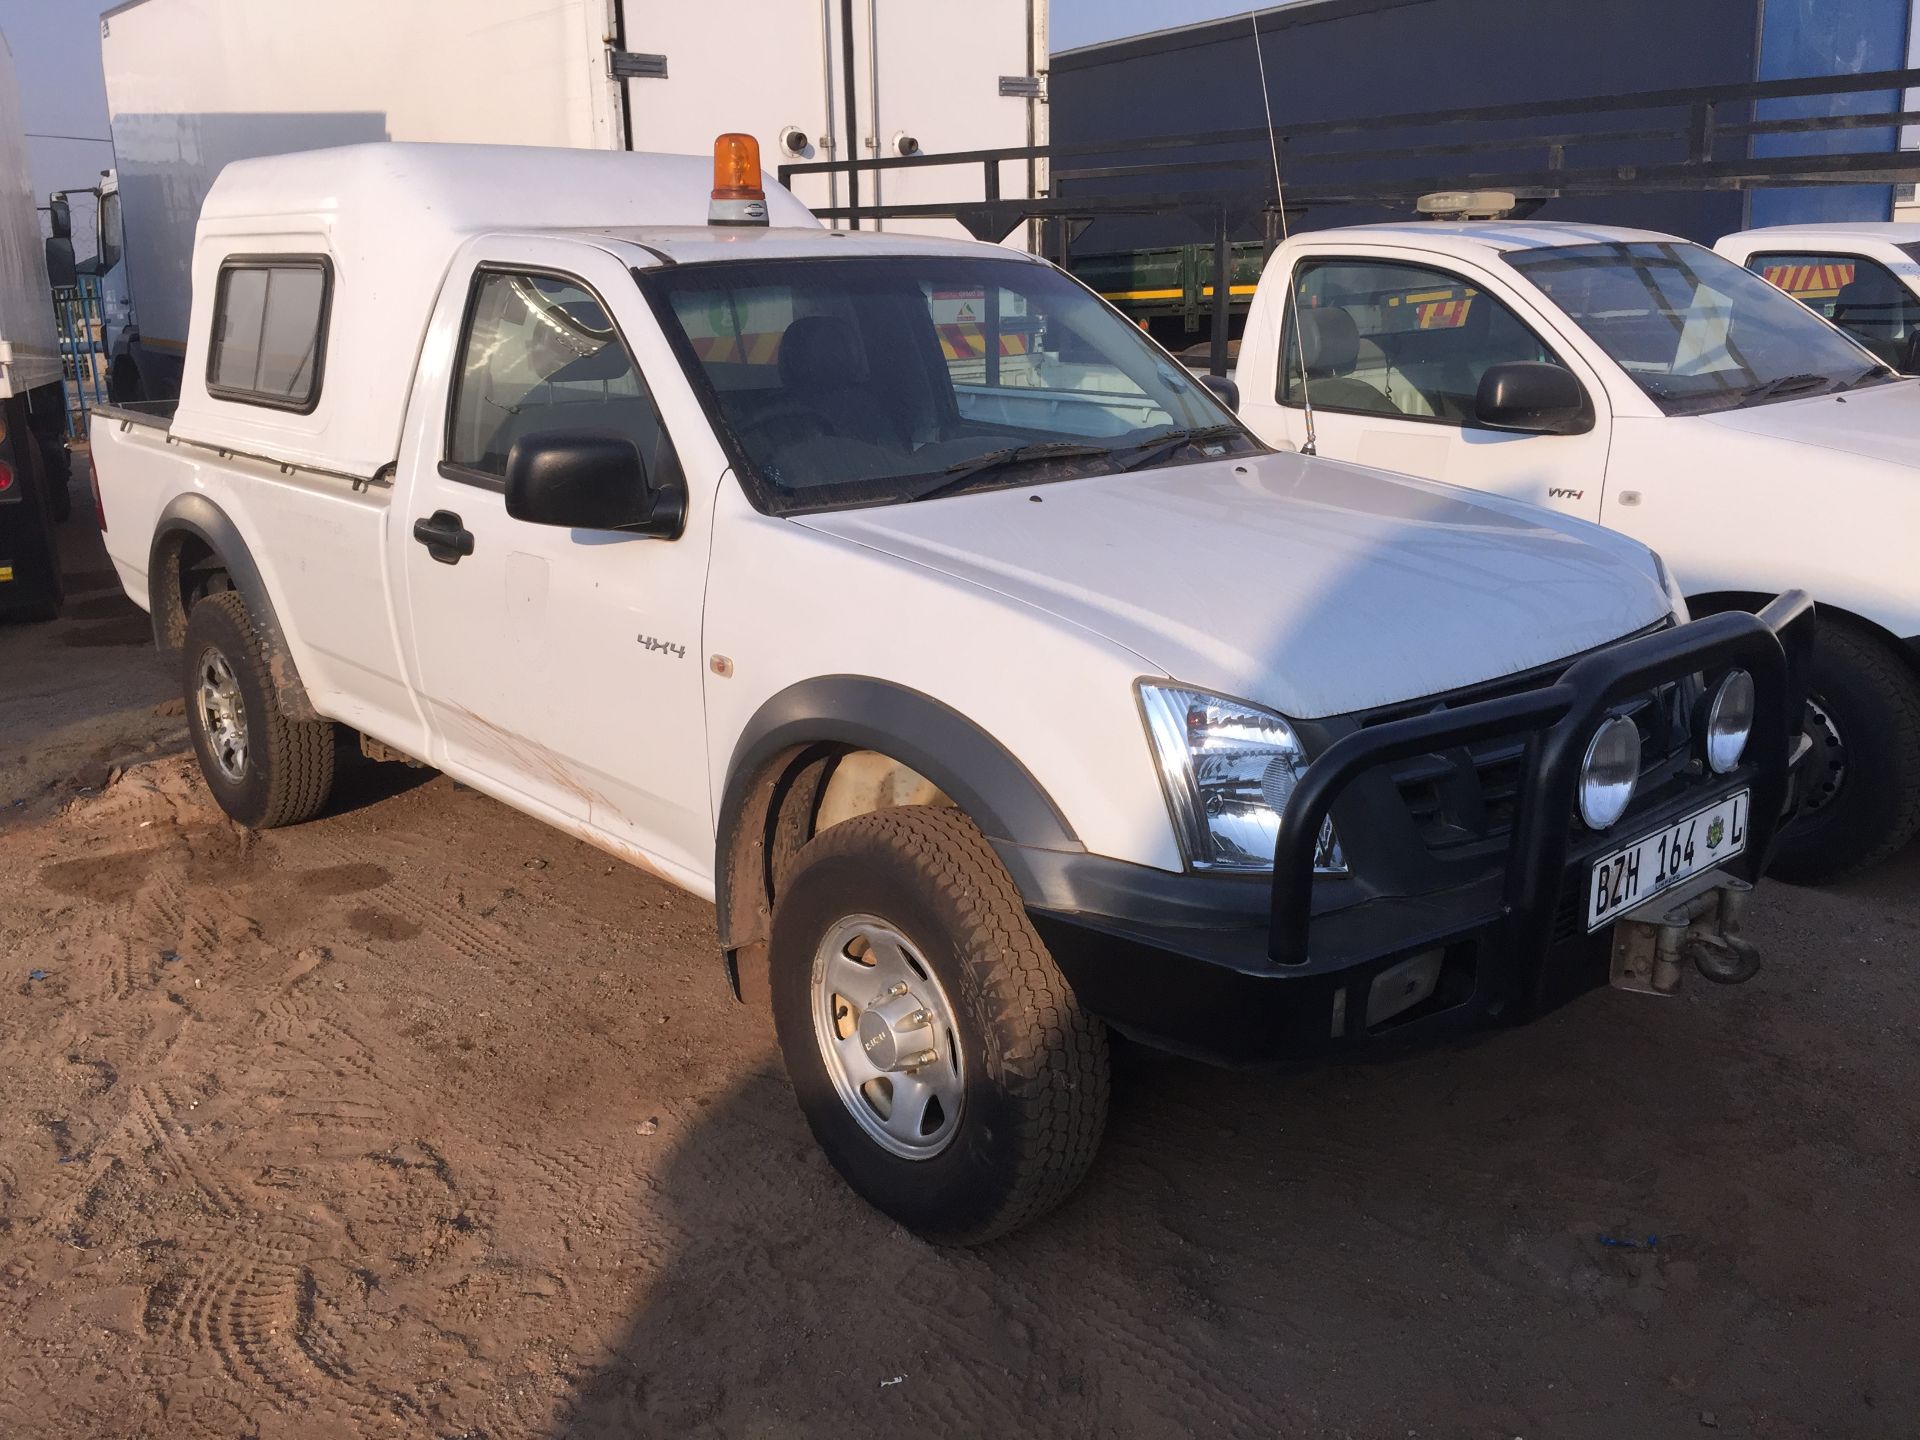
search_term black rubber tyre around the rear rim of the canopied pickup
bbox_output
[180,589,334,829]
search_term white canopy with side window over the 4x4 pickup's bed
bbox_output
[173,144,820,478]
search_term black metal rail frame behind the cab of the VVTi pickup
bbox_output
[780,69,1920,374]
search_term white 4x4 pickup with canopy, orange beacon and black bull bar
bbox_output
[92,146,1812,1242]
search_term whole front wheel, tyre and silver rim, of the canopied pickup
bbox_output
[770,806,1108,1244]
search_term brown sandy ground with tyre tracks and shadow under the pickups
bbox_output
[0,495,1920,1440]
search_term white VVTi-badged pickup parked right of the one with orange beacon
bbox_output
[1236,221,1920,881]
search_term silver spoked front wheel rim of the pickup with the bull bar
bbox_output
[812,916,966,1160]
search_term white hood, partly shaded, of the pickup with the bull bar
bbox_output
[797,455,1670,720]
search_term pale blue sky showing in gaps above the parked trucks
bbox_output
[0,0,1273,204]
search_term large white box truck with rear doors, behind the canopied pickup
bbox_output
[100,0,1046,397]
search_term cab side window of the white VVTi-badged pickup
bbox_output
[1277,257,1561,426]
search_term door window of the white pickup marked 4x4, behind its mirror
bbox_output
[445,269,678,490]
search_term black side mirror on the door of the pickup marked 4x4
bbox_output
[507,430,687,540]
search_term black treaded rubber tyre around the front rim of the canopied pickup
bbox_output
[770,806,1110,1244]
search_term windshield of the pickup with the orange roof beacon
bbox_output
[641,255,1258,511]
